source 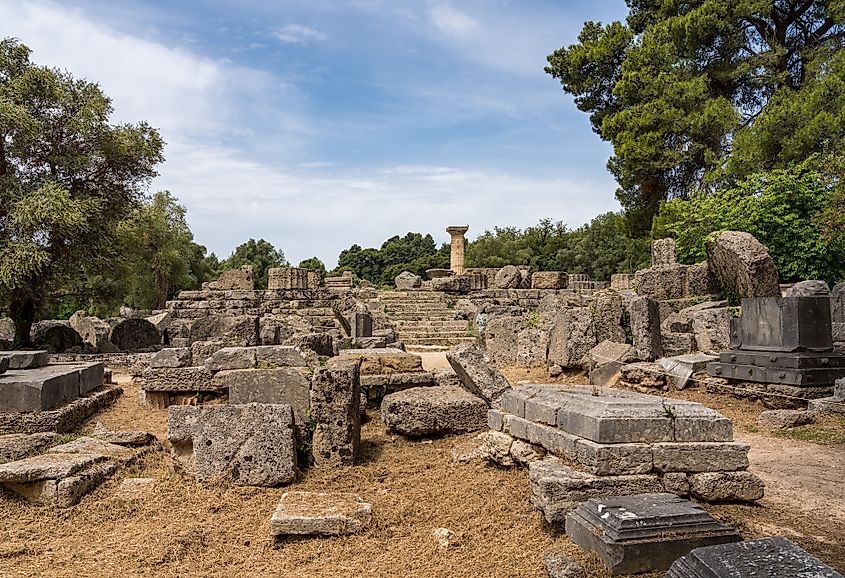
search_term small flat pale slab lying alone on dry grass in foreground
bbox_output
[270,492,373,537]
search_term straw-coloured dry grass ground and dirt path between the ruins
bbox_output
[0,370,845,578]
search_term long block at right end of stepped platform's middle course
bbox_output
[652,442,749,472]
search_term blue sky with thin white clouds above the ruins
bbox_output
[0,0,626,266]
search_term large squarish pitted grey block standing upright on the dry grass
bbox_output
[167,403,296,486]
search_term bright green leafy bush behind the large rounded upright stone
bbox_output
[652,157,845,283]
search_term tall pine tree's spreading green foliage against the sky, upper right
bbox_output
[545,0,845,235]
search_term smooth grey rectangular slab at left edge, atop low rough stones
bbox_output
[0,363,103,412]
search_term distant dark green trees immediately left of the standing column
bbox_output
[332,233,449,286]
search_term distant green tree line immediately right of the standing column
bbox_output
[466,213,650,280]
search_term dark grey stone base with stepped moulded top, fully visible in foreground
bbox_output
[566,493,742,575]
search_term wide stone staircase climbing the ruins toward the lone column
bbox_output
[379,291,478,352]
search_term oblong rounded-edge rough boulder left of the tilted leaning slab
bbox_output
[381,387,488,436]
